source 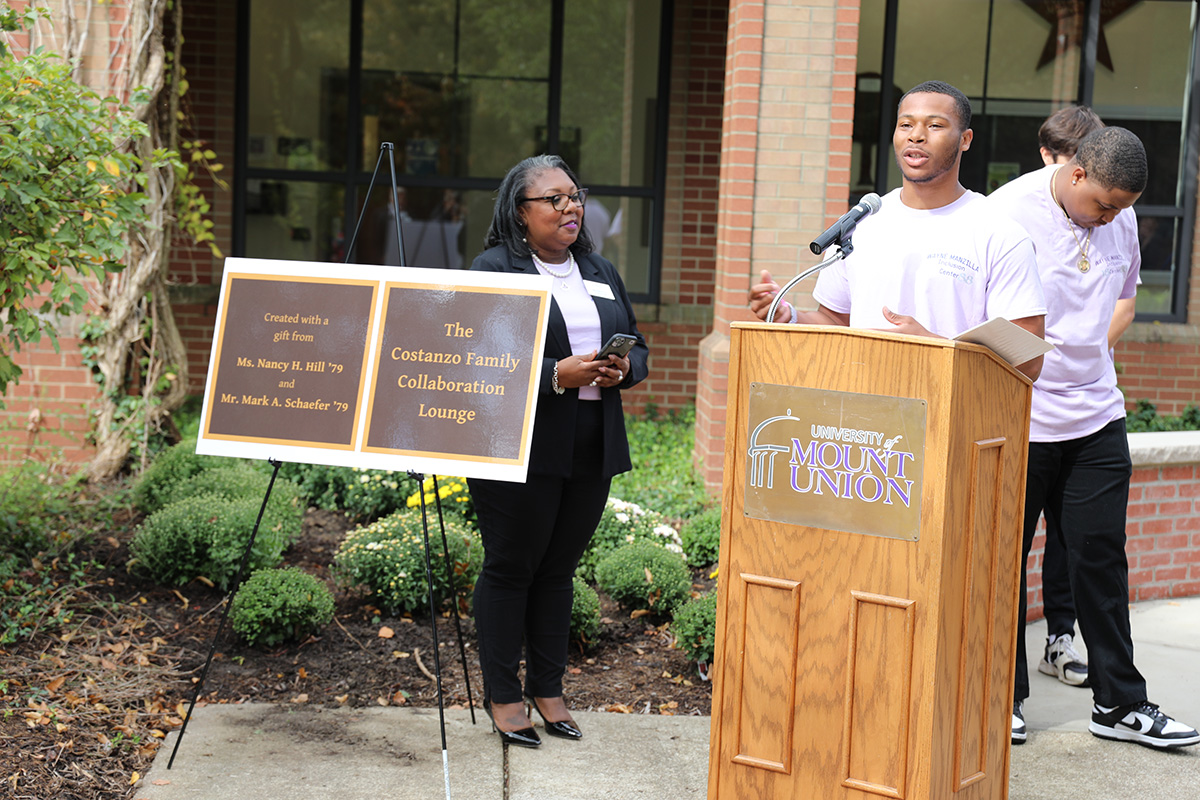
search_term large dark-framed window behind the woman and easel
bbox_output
[238,0,665,300]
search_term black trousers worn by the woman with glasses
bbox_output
[469,401,611,703]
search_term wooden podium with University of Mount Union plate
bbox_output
[708,323,1032,800]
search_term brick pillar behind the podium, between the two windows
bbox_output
[695,0,859,491]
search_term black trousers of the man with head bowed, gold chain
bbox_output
[1013,419,1146,706]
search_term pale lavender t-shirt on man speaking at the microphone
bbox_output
[812,190,1046,338]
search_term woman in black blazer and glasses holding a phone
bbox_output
[469,156,648,747]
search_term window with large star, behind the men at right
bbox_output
[851,0,1196,320]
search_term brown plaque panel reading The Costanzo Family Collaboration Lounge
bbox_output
[364,283,547,463]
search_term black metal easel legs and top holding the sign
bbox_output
[167,142,475,800]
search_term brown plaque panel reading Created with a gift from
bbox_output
[204,273,377,450]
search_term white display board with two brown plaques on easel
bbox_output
[197,258,550,481]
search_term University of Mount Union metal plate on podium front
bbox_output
[744,383,925,541]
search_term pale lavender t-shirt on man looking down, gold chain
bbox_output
[988,166,1141,441]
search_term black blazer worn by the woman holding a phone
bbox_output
[470,246,649,477]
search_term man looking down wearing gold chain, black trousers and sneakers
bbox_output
[988,127,1200,747]
